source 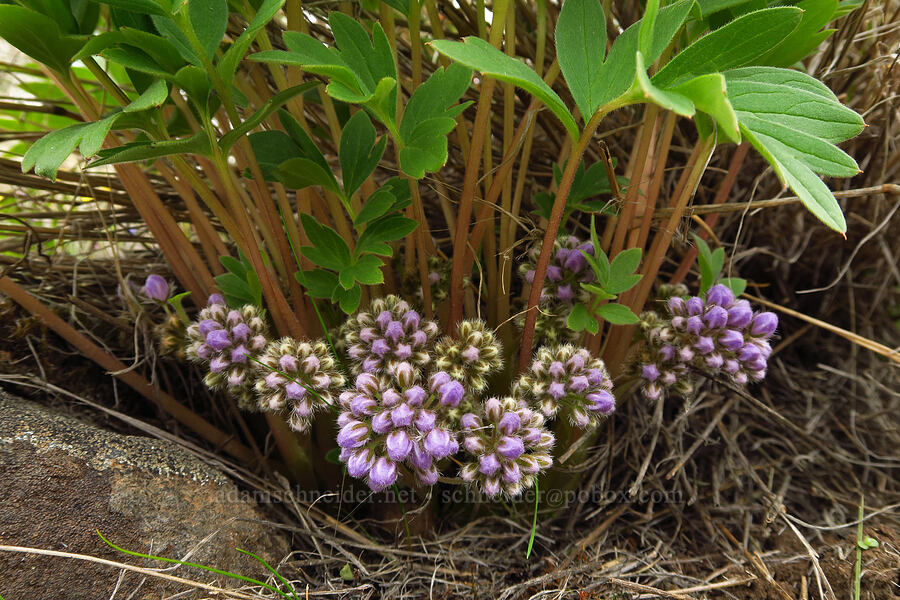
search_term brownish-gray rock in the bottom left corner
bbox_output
[0,390,289,600]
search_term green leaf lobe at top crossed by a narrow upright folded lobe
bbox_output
[594,0,694,106]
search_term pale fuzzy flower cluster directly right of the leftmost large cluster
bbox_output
[256,338,345,432]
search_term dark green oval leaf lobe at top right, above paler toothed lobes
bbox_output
[653,6,803,88]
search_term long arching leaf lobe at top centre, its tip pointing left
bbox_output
[431,37,578,139]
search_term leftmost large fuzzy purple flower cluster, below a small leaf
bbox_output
[187,294,267,409]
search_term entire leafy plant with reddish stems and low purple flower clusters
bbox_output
[0,0,864,520]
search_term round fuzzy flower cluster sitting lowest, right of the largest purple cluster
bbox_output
[459,398,555,497]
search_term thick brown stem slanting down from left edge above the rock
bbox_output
[0,277,260,465]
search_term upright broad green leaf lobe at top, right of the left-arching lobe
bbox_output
[555,0,606,121]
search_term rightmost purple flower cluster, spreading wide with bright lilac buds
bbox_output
[636,285,778,400]
